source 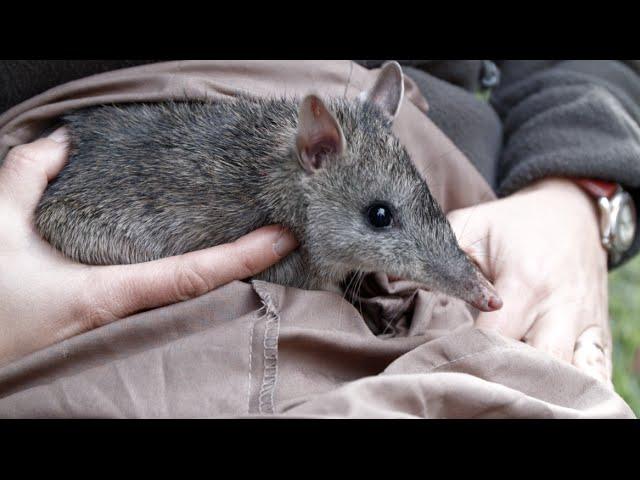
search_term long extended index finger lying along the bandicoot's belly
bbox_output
[85,225,297,321]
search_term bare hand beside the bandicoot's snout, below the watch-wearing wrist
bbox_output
[448,179,611,383]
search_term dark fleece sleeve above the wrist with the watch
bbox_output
[491,60,640,267]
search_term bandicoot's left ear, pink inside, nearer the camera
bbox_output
[296,95,345,172]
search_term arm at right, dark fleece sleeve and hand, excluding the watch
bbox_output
[450,61,640,377]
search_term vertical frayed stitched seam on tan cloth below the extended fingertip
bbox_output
[256,286,280,413]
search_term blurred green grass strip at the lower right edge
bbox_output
[609,255,640,417]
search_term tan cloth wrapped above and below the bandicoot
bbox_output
[0,61,633,418]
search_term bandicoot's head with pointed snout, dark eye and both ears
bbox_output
[295,62,502,311]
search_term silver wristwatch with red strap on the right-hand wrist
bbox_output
[576,178,637,264]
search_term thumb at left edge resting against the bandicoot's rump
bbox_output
[0,128,68,215]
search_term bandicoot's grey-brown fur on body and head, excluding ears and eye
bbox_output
[36,63,500,306]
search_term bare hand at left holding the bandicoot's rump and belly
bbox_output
[0,130,297,365]
